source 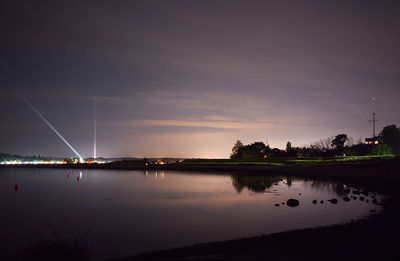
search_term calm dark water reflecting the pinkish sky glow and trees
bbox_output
[0,168,380,259]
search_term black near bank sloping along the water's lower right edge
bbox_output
[114,202,400,261]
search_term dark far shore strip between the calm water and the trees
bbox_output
[4,154,400,191]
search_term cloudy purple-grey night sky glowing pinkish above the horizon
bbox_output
[0,1,400,158]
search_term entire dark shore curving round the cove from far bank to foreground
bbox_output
[2,158,400,261]
